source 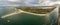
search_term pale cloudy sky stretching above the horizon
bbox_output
[0,0,60,6]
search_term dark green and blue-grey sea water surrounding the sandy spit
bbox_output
[0,7,56,25]
